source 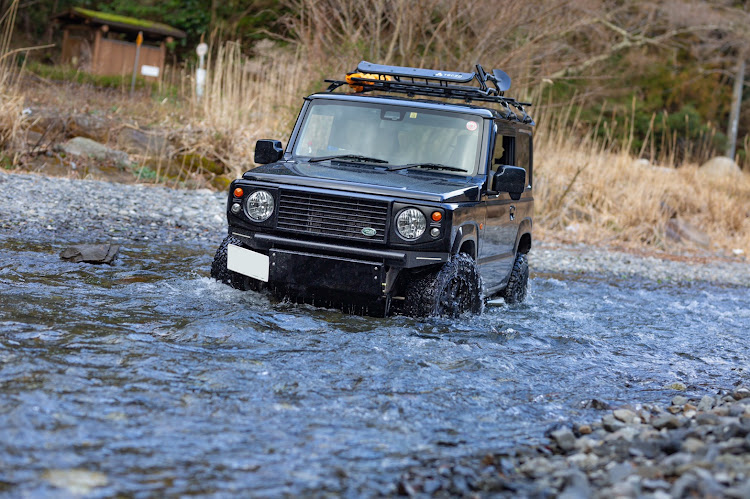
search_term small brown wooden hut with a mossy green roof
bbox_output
[55,7,185,79]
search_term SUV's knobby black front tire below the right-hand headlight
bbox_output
[404,253,482,317]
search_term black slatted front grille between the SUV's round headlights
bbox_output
[276,191,388,242]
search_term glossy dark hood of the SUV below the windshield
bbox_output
[242,161,482,203]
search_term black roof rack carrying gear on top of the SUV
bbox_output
[325,61,534,125]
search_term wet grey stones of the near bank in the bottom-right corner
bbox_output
[392,387,750,499]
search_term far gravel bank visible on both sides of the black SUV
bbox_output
[0,172,750,286]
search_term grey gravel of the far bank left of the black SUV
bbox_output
[0,171,226,244]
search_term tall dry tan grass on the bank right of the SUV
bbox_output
[532,91,750,254]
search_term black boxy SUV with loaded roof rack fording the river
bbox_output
[211,61,534,316]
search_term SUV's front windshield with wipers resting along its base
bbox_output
[294,100,483,175]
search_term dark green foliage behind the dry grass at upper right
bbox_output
[544,56,732,164]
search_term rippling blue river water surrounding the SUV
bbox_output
[0,238,750,497]
